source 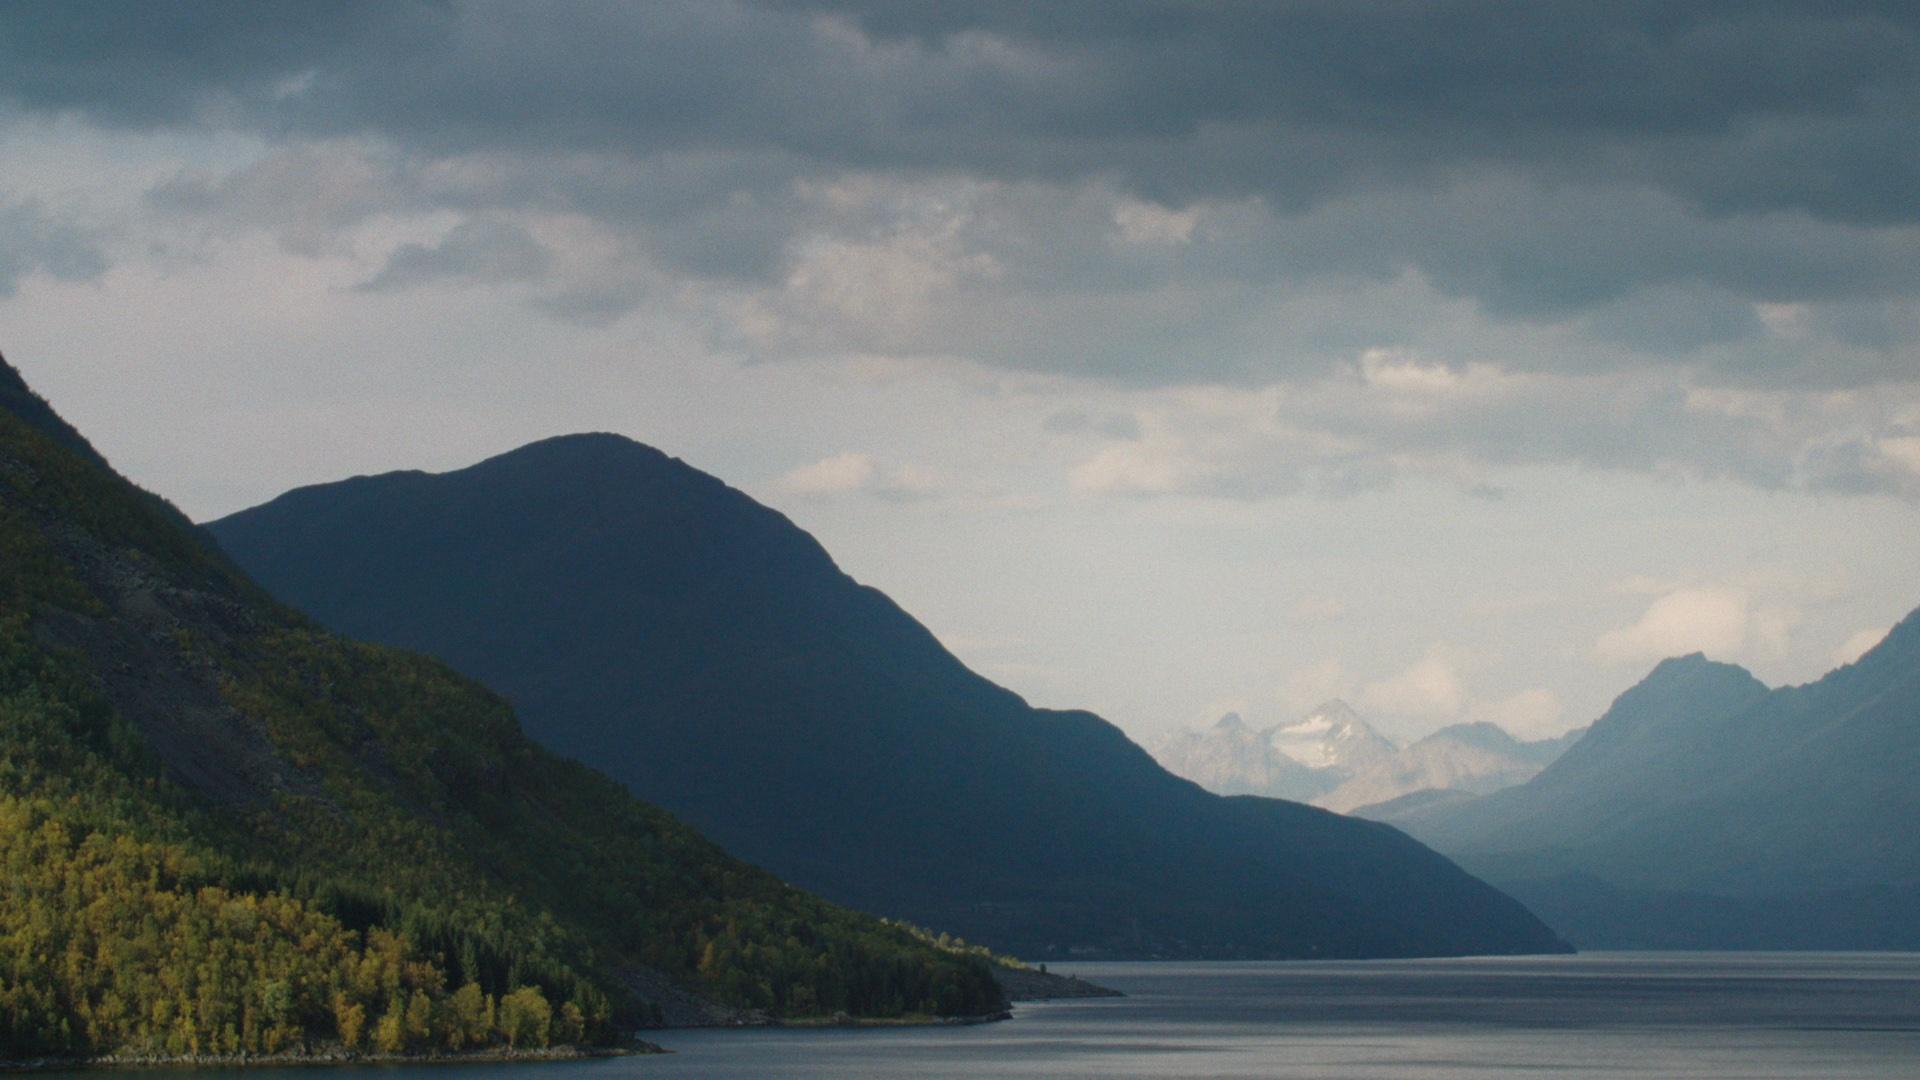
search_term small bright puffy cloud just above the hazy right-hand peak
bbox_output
[1594,586,1801,665]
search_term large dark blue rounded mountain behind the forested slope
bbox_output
[209,434,1561,959]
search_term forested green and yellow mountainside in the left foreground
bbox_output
[0,361,1002,1061]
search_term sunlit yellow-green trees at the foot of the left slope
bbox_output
[0,798,583,1057]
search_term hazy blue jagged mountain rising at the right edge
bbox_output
[1386,634,1920,949]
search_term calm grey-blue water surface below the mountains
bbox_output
[71,953,1920,1080]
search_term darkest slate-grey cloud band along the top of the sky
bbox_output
[15,0,1920,223]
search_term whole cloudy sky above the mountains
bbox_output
[0,0,1920,744]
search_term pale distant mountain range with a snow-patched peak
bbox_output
[1154,700,1580,813]
